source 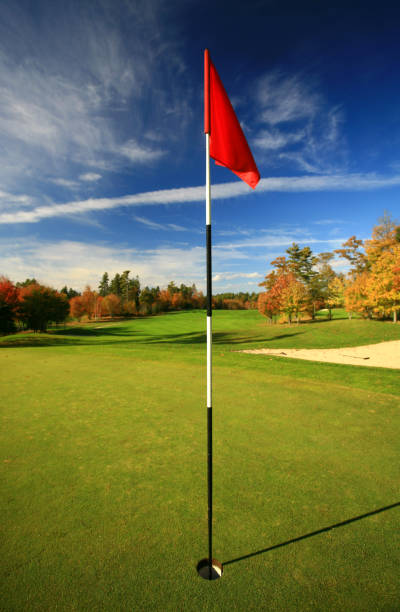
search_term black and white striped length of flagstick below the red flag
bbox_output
[206,134,212,580]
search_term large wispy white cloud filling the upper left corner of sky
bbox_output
[0,0,191,191]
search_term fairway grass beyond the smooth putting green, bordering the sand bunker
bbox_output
[0,311,400,395]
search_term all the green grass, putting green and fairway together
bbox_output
[0,311,400,611]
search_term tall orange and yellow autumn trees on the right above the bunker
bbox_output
[257,213,400,323]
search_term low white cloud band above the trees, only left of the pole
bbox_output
[0,239,205,290]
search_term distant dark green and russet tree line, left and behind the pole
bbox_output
[0,270,257,333]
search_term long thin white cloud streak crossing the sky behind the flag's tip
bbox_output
[0,174,400,224]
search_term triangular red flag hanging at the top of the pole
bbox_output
[204,49,260,189]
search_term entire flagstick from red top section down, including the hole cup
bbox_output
[197,49,223,580]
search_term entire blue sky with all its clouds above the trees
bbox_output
[0,0,400,293]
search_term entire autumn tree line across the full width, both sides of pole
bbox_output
[0,214,400,333]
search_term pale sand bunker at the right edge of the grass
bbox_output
[240,340,400,369]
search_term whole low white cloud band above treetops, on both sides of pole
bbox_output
[0,228,347,291]
